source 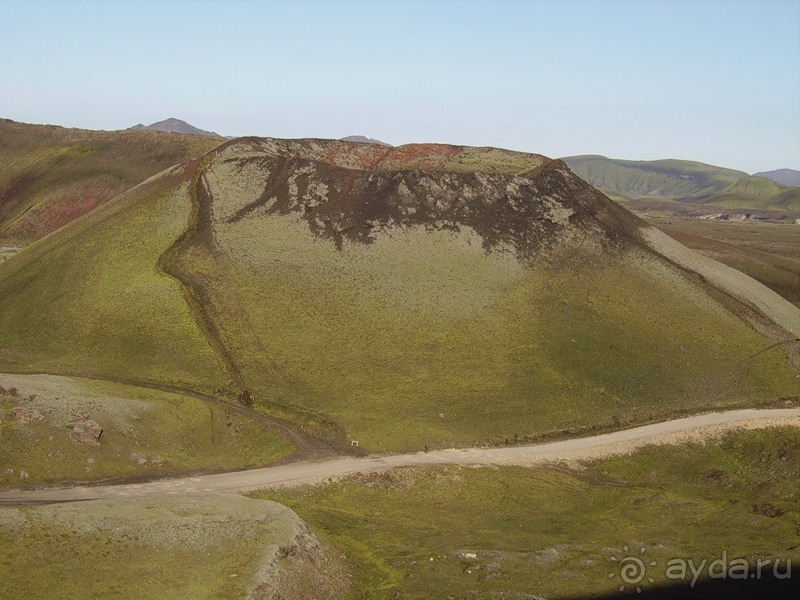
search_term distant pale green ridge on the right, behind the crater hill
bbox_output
[562,155,747,199]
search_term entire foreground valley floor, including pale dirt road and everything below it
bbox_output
[0,407,800,600]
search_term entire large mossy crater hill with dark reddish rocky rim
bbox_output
[0,138,800,451]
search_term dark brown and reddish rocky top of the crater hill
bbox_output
[199,138,644,258]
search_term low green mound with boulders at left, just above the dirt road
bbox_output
[0,373,292,486]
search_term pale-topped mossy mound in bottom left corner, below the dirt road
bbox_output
[0,494,348,600]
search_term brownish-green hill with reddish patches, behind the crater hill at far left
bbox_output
[0,119,222,243]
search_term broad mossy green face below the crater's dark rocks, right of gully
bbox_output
[191,222,798,450]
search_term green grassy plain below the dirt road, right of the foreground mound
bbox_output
[254,427,800,598]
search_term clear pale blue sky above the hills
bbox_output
[0,0,800,172]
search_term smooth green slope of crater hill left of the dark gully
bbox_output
[0,163,226,390]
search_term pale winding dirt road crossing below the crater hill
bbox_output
[0,408,800,504]
